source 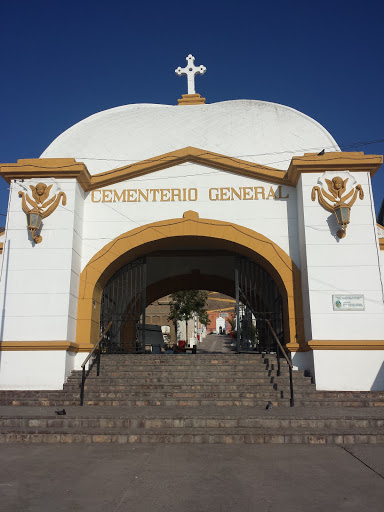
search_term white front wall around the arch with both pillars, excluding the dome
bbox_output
[0,164,384,389]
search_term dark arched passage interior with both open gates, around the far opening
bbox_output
[100,252,284,353]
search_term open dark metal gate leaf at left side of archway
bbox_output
[100,258,147,354]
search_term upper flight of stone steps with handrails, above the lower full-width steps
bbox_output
[0,354,384,407]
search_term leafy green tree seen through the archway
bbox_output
[168,290,209,341]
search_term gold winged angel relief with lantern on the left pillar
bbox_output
[19,183,67,244]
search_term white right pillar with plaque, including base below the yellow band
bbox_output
[294,173,384,390]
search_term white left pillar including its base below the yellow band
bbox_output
[0,178,83,389]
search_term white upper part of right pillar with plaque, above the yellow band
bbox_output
[298,173,384,341]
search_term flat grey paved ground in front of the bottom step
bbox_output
[0,445,384,512]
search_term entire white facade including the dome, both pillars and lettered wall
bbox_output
[0,100,384,390]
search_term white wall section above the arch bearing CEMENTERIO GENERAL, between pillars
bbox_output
[82,163,300,268]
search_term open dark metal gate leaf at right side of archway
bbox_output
[235,258,284,353]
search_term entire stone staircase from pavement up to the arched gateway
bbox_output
[0,354,384,444]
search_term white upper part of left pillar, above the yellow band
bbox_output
[0,179,82,341]
